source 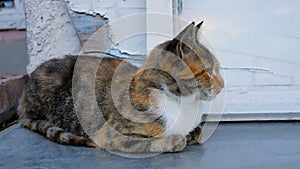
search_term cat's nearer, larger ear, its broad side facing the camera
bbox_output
[175,22,196,46]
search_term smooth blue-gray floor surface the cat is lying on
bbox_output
[0,122,300,169]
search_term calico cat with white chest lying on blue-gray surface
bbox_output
[18,21,224,153]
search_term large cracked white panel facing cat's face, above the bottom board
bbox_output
[179,0,300,87]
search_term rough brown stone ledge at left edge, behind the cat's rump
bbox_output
[0,75,26,126]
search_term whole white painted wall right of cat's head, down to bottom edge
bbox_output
[179,0,300,120]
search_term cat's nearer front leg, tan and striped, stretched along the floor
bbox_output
[93,125,187,153]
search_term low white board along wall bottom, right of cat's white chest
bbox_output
[206,86,300,121]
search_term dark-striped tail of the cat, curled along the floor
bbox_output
[20,119,96,147]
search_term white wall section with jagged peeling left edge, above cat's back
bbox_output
[68,0,146,55]
